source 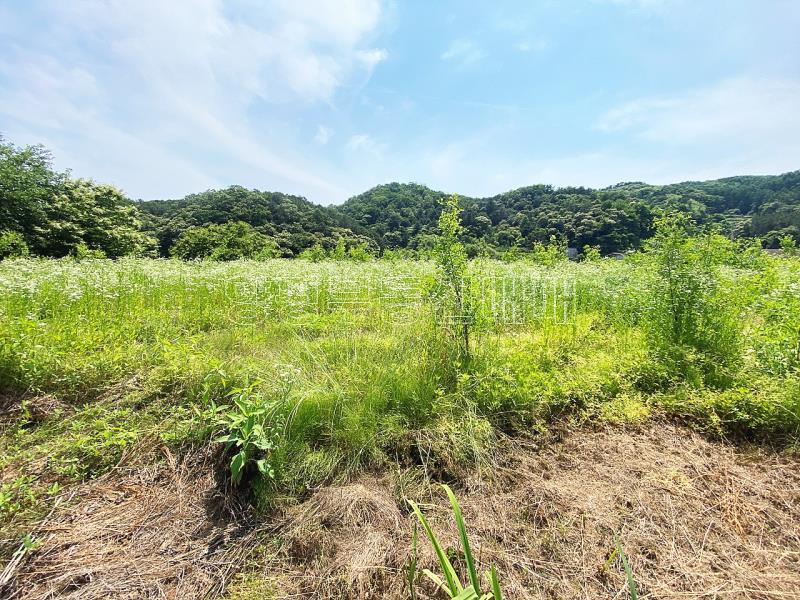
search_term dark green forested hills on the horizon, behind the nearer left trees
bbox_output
[133,171,800,256]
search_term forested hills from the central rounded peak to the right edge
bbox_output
[335,171,800,253]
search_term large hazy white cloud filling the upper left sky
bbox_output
[0,0,386,198]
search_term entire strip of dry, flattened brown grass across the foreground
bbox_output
[6,423,800,599]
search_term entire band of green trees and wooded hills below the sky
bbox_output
[0,138,800,260]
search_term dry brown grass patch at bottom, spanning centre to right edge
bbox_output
[264,425,800,599]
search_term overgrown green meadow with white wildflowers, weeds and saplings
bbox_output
[0,220,800,546]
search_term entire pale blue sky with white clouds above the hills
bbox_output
[0,0,800,204]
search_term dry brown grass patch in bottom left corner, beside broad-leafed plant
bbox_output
[0,448,254,600]
